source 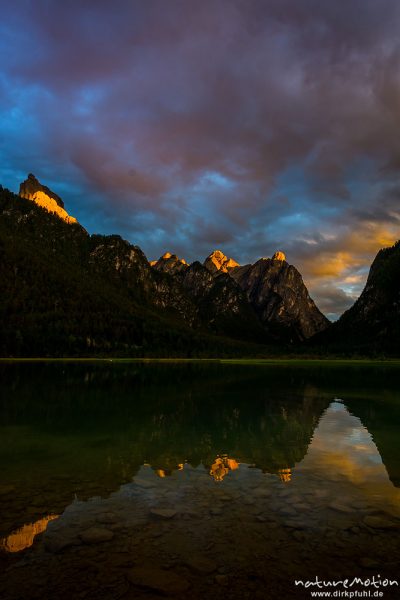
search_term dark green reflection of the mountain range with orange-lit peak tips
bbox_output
[0,363,400,529]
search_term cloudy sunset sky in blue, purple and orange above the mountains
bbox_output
[0,0,400,319]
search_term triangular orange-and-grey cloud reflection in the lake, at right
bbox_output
[296,401,391,485]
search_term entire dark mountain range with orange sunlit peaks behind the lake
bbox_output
[0,174,400,356]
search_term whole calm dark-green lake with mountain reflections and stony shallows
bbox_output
[0,361,400,600]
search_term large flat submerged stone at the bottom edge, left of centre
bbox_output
[128,566,190,596]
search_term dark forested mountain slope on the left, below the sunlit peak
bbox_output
[0,183,272,356]
